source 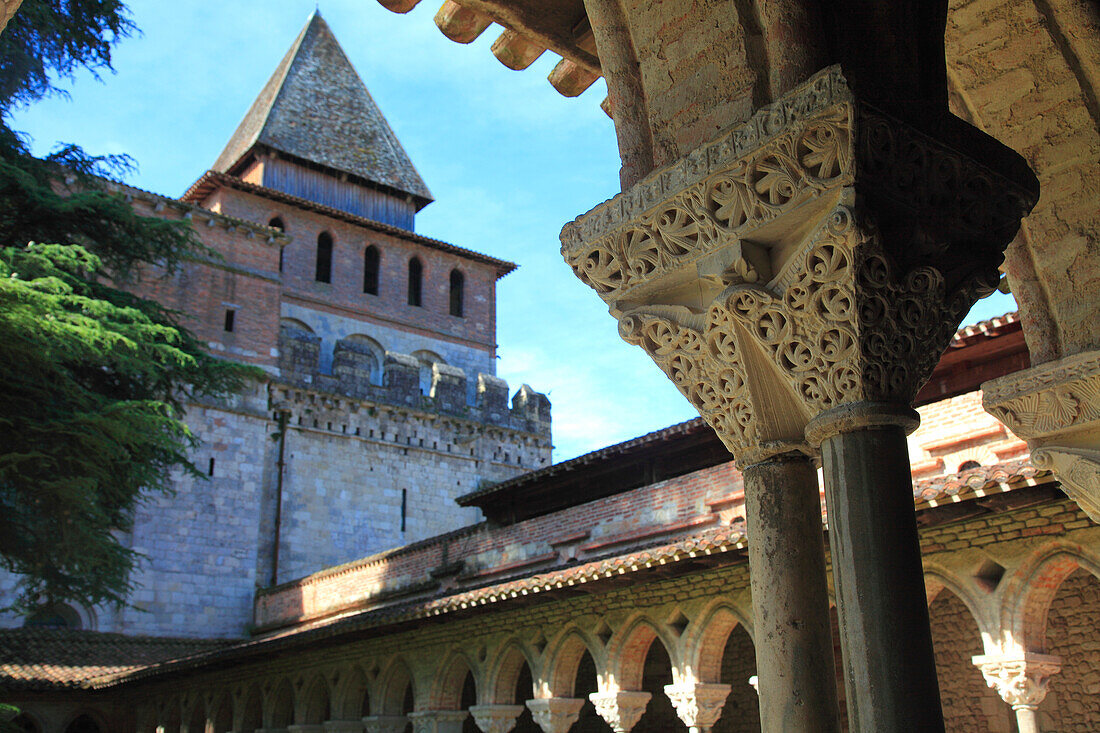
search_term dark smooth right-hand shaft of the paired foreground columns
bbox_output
[818,425,944,733]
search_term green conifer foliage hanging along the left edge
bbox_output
[0,0,250,611]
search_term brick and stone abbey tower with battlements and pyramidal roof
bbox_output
[0,13,551,637]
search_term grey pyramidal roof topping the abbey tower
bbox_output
[213,12,432,208]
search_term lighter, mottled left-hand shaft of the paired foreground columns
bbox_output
[744,453,839,733]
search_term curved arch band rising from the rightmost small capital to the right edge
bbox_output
[1001,540,1100,653]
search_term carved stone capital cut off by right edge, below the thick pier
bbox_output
[981,351,1100,522]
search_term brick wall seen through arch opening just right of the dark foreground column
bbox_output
[928,572,1012,733]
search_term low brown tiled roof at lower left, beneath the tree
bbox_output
[0,628,231,691]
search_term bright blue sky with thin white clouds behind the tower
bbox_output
[13,0,1015,461]
